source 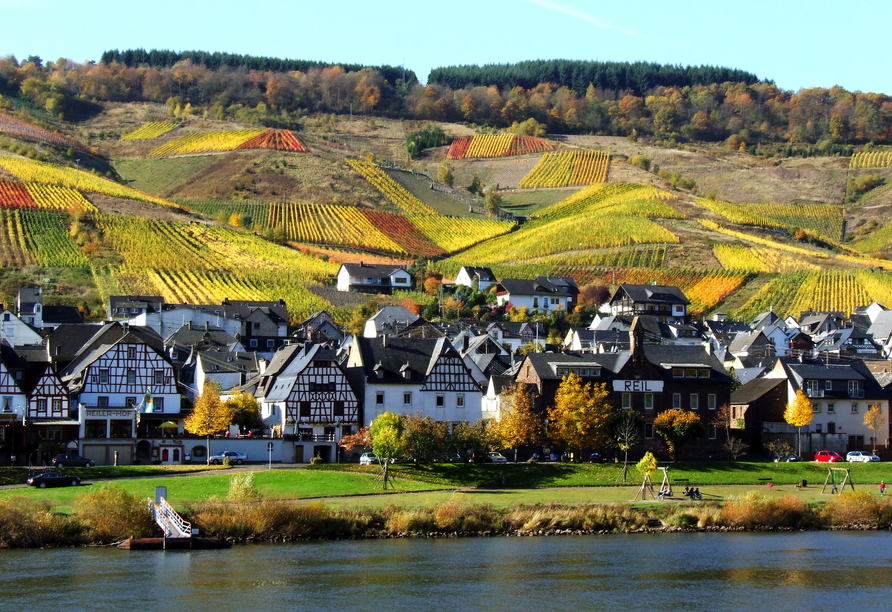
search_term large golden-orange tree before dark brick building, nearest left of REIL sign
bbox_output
[548,372,613,460]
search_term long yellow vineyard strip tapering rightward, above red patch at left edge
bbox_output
[0,155,186,208]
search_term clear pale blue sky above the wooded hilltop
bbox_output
[0,0,892,94]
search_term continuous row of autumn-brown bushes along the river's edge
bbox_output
[8,486,892,548]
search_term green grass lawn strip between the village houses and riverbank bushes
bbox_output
[6,462,892,512]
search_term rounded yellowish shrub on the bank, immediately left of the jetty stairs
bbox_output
[74,485,157,542]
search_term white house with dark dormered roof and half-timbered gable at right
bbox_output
[347,336,483,425]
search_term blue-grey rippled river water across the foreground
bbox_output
[0,532,892,612]
